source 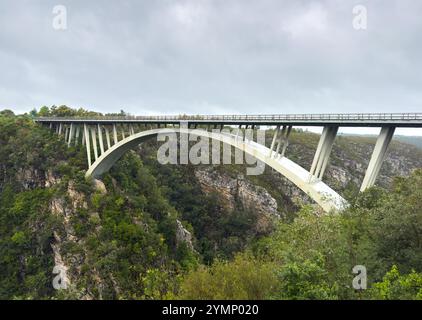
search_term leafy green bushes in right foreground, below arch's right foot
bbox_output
[181,170,422,299]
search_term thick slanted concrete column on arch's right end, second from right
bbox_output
[309,126,338,182]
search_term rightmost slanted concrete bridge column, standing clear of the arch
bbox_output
[360,127,395,191]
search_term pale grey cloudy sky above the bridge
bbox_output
[0,0,422,129]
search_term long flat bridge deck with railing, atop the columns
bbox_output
[35,113,422,127]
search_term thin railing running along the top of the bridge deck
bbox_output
[35,113,422,122]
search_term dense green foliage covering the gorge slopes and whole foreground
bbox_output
[0,106,422,299]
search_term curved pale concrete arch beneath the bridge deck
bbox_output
[86,128,347,212]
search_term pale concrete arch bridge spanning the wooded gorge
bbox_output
[34,113,422,212]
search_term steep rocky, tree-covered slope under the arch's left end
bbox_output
[0,115,198,299]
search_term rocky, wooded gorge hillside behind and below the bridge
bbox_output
[0,110,422,299]
